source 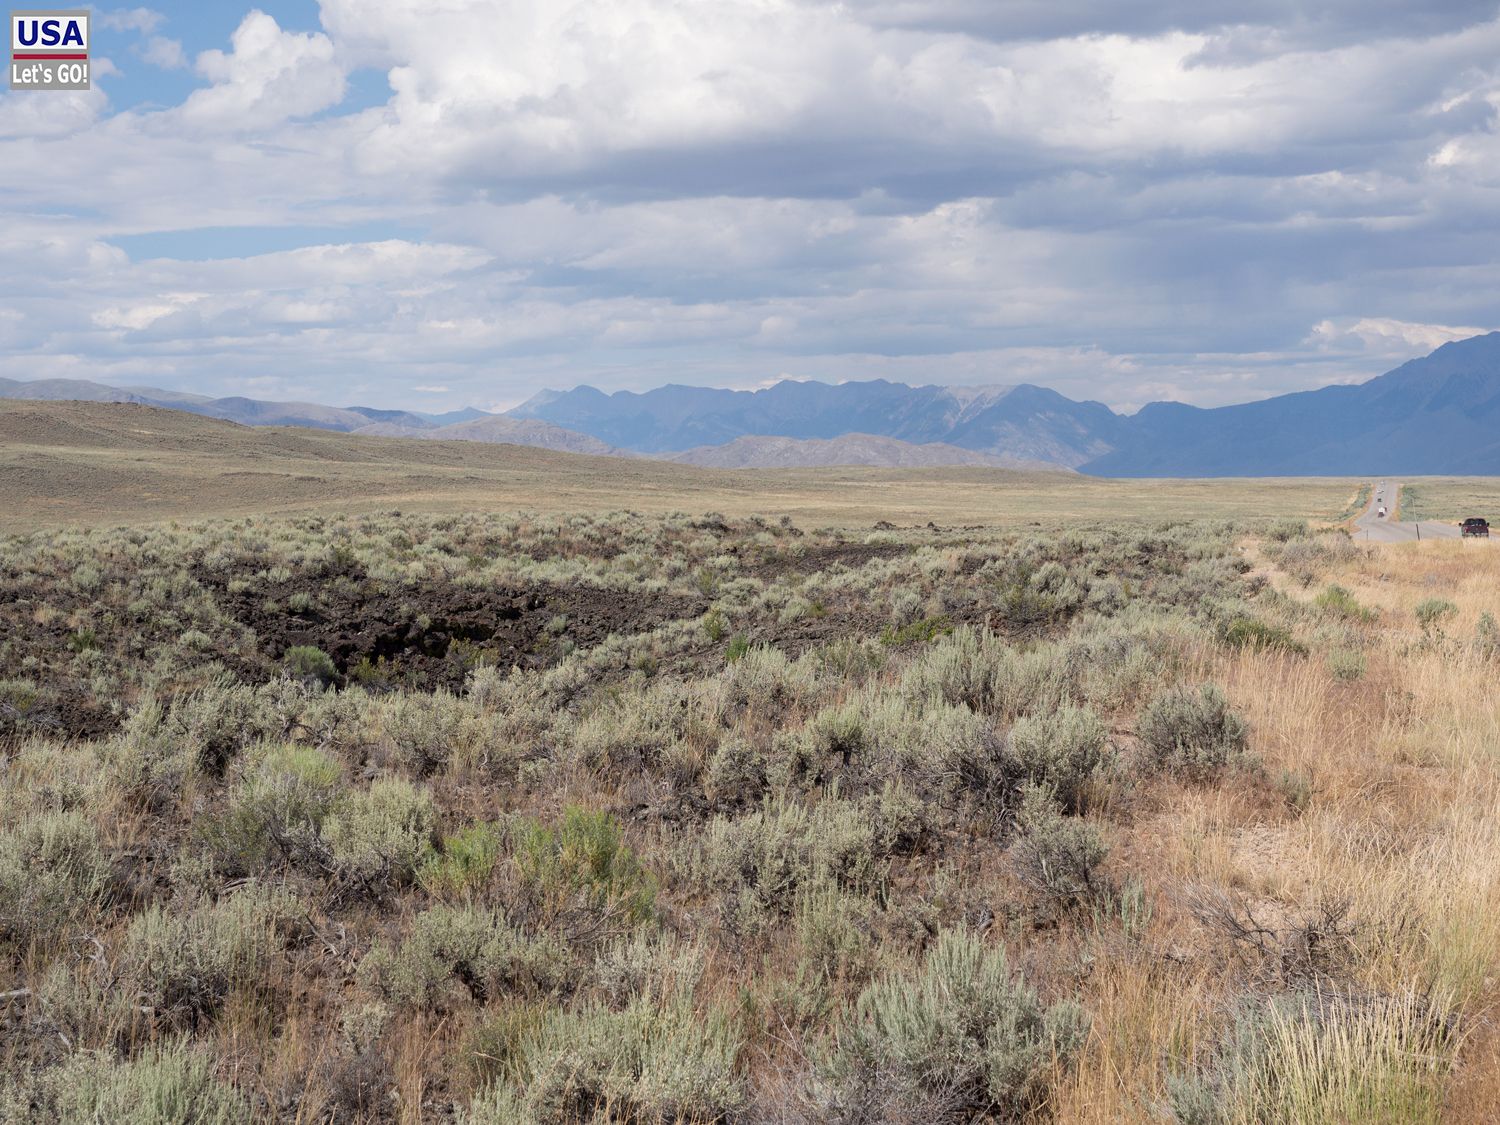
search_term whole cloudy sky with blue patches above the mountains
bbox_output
[0,0,1500,411]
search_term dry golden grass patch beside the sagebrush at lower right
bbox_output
[1059,542,1500,1122]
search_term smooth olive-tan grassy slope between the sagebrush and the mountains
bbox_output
[0,401,1358,531]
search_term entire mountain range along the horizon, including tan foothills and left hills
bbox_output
[0,333,1500,477]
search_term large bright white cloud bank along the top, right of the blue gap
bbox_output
[313,0,1500,190]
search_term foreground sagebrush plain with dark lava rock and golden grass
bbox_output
[0,495,1500,1125]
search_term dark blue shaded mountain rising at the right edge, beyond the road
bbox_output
[1082,333,1500,477]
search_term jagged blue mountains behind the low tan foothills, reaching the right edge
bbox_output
[510,333,1500,477]
